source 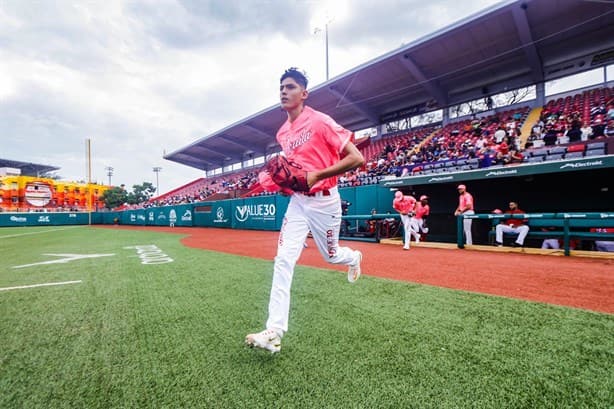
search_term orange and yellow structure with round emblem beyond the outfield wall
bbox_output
[0,176,109,212]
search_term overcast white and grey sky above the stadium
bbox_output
[0,0,498,193]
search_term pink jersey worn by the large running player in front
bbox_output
[258,106,354,192]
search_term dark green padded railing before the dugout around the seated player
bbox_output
[457,212,614,256]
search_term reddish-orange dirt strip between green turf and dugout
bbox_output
[106,226,614,314]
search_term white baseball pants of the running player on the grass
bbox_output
[266,188,358,335]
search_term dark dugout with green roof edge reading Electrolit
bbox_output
[379,156,614,246]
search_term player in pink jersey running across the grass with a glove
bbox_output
[245,68,364,353]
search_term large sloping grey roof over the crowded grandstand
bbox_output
[164,0,614,171]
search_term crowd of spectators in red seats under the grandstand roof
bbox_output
[127,88,614,208]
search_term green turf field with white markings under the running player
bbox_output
[0,227,614,409]
